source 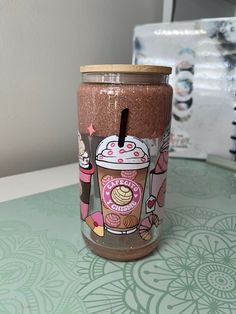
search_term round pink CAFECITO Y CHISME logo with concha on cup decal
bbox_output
[102,178,142,215]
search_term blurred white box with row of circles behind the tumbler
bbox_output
[133,18,236,160]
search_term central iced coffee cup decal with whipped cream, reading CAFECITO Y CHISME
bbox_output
[96,135,150,234]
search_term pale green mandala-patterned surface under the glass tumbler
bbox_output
[0,160,236,314]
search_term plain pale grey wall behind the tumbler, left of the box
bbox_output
[0,0,162,176]
